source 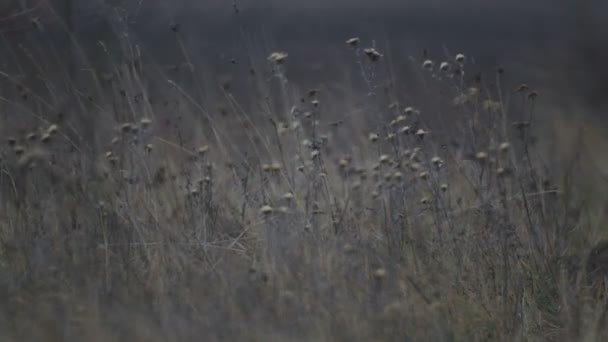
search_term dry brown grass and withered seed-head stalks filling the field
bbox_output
[0,5,608,341]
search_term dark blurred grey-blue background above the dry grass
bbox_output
[0,0,608,130]
